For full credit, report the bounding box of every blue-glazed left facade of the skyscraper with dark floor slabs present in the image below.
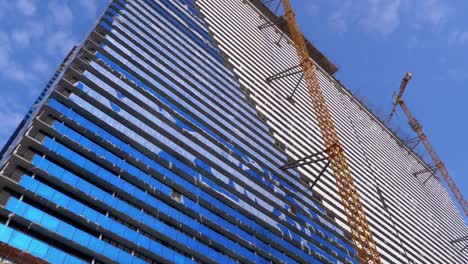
[0,0,358,264]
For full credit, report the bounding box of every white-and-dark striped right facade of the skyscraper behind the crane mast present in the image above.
[197,0,468,264]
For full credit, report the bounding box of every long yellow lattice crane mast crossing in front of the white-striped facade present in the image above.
[281,0,381,264]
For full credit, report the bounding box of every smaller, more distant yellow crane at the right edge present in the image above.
[387,73,468,216]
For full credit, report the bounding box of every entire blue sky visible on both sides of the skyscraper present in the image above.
[0,0,468,212]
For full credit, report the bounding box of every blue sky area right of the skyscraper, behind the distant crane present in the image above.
[292,0,468,208]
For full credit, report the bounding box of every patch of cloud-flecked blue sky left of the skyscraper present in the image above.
[0,0,107,146]
